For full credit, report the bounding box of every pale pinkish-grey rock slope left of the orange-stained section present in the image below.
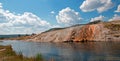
[29,26,82,42]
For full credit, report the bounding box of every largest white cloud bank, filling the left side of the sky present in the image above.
[0,3,50,34]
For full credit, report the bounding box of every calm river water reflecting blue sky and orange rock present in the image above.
[0,41,120,61]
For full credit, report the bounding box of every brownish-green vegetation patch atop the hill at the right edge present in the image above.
[105,21,120,31]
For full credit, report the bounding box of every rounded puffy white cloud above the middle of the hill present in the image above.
[56,7,82,25]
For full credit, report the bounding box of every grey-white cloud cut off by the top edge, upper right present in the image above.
[80,0,113,13]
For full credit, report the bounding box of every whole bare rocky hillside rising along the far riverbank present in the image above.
[24,21,120,42]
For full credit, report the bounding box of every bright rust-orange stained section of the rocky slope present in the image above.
[75,25,101,41]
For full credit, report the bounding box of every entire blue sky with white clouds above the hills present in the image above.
[0,0,120,34]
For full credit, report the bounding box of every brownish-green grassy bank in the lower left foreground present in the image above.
[0,45,43,61]
